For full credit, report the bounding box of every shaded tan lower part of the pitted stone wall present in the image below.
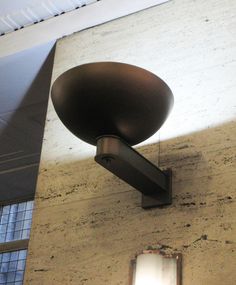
[26,119,236,285]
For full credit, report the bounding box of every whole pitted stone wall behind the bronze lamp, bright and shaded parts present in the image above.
[25,0,236,285]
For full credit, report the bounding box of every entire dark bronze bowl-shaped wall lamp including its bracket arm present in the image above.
[52,62,174,208]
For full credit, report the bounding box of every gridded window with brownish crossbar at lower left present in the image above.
[0,201,34,285]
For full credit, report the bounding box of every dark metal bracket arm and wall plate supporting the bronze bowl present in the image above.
[95,136,172,209]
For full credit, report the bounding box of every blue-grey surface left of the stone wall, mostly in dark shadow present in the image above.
[0,42,55,203]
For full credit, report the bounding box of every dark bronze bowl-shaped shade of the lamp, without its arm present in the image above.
[52,62,173,145]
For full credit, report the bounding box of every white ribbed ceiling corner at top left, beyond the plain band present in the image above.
[0,0,97,35]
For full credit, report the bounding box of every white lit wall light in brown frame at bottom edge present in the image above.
[129,250,182,285]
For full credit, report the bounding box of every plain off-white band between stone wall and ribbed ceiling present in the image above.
[0,0,170,57]
